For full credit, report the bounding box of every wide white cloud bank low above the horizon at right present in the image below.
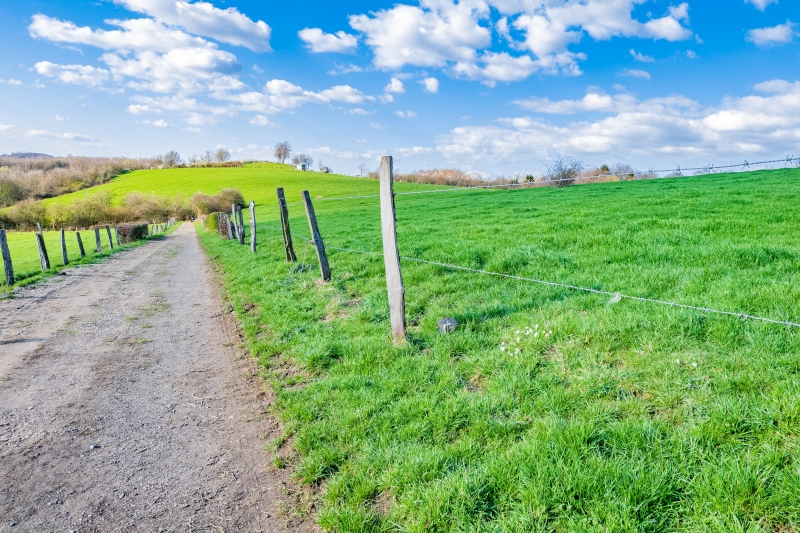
[437,80,800,163]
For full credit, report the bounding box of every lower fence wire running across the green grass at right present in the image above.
[260,227,800,328]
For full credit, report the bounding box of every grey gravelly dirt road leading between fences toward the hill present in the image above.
[0,224,308,532]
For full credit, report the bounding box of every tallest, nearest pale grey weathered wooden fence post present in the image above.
[380,156,406,341]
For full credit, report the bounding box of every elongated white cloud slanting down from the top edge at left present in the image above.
[115,0,272,52]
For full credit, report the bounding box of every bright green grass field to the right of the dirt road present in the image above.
[198,165,800,533]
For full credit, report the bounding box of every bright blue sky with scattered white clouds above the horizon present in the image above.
[0,0,800,175]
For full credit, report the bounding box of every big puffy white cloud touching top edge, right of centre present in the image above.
[349,0,692,85]
